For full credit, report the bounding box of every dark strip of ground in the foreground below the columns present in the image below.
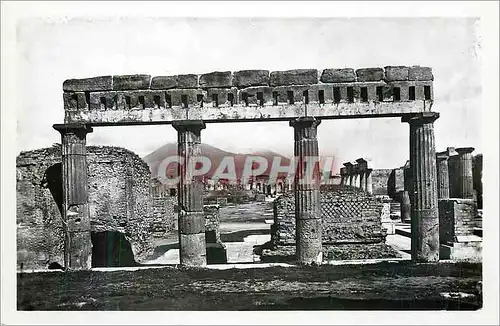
[17,262,482,310]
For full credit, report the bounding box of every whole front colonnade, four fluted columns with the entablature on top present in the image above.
[38,66,439,269]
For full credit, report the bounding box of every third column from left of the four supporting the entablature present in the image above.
[290,117,323,264]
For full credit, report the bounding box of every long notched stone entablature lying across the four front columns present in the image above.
[63,66,433,125]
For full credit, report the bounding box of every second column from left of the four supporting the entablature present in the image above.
[172,120,207,266]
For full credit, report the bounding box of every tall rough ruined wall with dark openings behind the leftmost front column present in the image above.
[17,146,172,268]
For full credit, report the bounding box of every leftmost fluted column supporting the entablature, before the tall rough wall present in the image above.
[53,124,92,270]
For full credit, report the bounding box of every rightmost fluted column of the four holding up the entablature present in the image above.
[402,112,439,262]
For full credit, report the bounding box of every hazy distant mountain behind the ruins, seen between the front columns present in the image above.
[143,143,334,183]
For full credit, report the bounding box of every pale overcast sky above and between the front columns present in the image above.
[17,18,483,168]
